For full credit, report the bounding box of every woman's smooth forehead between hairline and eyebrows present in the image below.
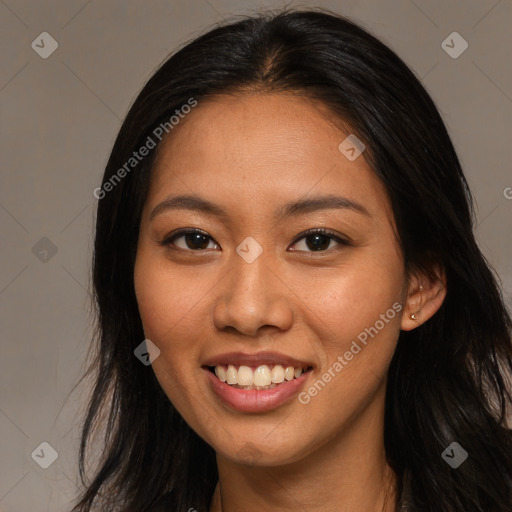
[148,93,389,217]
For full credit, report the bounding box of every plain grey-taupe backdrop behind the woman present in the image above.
[0,0,512,512]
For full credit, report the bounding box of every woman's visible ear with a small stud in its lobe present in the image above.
[401,265,446,331]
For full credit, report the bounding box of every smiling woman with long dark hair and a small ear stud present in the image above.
[74,11,512,512]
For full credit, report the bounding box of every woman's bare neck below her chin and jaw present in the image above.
[210,384,396,512]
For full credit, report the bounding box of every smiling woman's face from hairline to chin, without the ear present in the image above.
[135,94,407,465]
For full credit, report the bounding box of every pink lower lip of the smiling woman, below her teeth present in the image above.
[203,368,311,412]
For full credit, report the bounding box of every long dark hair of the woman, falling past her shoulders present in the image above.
[73,10,512,512]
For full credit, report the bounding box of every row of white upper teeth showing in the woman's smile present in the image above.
[215,364,304,389]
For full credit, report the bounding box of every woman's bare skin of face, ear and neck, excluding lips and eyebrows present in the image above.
[134,93,445,512]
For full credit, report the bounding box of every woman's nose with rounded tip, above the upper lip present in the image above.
[213,247,294,337]
